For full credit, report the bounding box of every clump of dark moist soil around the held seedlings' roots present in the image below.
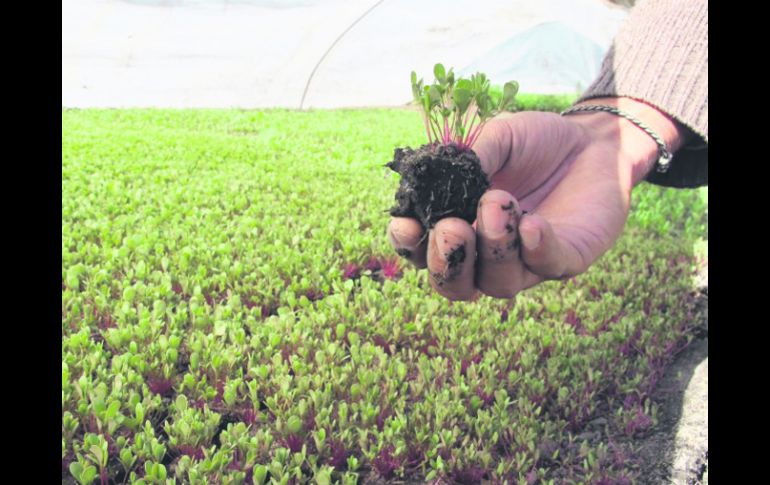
[385,145,489,229]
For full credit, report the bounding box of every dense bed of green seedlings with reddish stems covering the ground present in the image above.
[61,110,708,484]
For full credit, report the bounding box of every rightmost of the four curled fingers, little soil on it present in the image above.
[519,214,582,279]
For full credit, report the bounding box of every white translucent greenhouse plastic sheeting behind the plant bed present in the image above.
[62,0,628,108]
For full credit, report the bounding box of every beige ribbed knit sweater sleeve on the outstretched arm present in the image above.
[580,0,708,187]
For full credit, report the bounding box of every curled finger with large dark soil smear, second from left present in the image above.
[427,217,476,300]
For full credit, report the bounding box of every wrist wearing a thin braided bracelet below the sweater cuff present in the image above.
[570,97,689,185]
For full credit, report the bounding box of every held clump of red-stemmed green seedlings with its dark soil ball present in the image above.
[386,64,519,229]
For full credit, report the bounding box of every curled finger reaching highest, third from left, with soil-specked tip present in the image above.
[476,190,537,298]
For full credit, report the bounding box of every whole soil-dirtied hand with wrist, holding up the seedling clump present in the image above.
[388,98,685,300]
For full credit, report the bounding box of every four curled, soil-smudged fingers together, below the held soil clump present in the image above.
[388,200,586,300]
